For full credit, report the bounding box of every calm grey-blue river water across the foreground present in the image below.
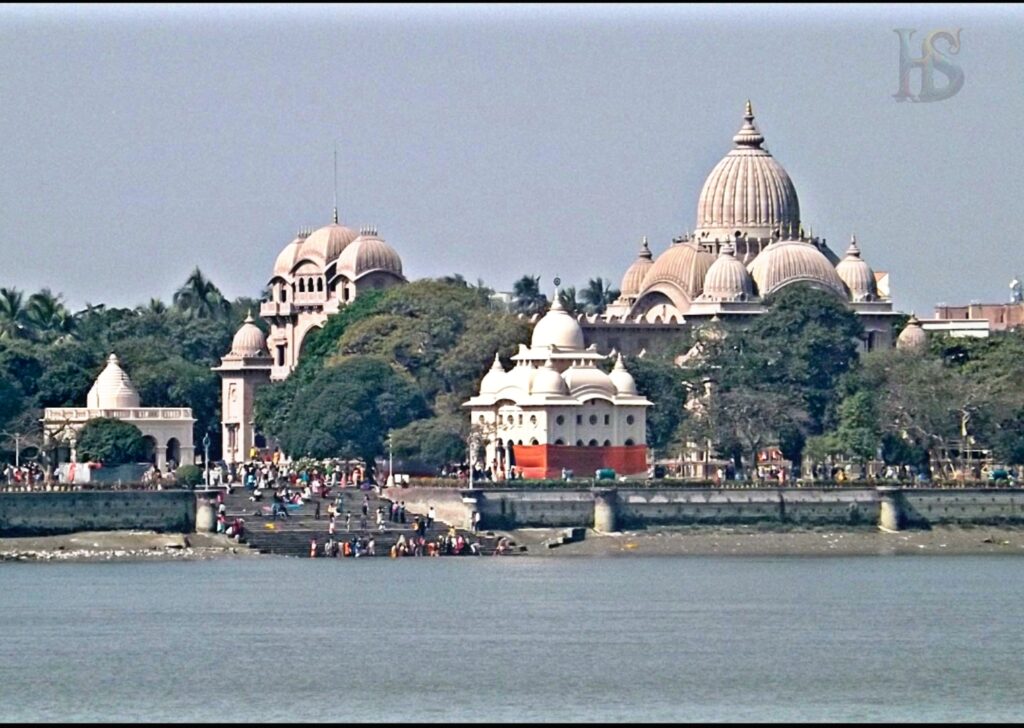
[0,556,1024,722]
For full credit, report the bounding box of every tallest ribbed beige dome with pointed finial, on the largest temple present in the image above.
[695,101,800,241]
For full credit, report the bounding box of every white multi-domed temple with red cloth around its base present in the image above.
[463,296,651,478]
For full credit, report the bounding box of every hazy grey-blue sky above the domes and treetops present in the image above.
[0,4,1024,315]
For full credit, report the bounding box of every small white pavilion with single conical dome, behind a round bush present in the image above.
[43,354,196,471]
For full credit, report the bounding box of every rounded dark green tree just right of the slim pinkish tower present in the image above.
[281,356,429,470]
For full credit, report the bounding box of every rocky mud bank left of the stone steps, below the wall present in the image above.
[0,531,258,561]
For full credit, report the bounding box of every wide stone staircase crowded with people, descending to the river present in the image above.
[224,487,516,558]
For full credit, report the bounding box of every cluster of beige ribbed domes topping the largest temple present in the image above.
[615,101,886,320]
